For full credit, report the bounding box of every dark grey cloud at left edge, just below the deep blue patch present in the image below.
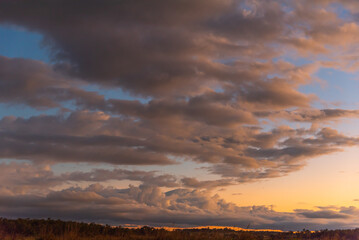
[0,56,108,109]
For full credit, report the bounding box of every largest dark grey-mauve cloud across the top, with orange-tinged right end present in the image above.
[0,0,326,100]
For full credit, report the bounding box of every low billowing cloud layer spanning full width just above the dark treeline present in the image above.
[0,163,359,230]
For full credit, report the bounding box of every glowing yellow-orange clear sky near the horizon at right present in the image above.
[220,147,359,211]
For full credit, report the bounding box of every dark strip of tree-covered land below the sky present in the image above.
[0,218,359,240]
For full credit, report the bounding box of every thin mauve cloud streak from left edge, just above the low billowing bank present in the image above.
[0,162,181,196]
